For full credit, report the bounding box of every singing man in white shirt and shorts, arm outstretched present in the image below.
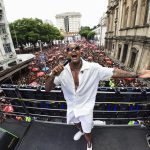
[45,43,150,150]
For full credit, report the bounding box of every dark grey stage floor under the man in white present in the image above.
[0,120,150,150]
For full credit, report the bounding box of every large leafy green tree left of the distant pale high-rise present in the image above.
[9,18,63,46]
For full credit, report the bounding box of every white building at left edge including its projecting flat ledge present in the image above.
[0,0,34,83]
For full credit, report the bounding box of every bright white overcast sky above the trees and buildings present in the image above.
[3,0,108,27]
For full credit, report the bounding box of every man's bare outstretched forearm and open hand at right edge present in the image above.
[112,68,150,78]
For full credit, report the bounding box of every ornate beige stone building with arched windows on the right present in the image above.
[105,0,150,72]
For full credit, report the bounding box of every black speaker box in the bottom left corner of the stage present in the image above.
[0,128,19,150]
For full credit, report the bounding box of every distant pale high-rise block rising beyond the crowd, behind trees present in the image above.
[56,12,81,34]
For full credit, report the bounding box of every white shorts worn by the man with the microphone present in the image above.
[69,112,93,133]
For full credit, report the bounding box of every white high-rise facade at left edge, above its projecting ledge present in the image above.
[0,0,17,71]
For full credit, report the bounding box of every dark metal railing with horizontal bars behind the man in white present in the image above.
[0,84,150,123]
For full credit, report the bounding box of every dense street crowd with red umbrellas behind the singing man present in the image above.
[16,41,147,87]
